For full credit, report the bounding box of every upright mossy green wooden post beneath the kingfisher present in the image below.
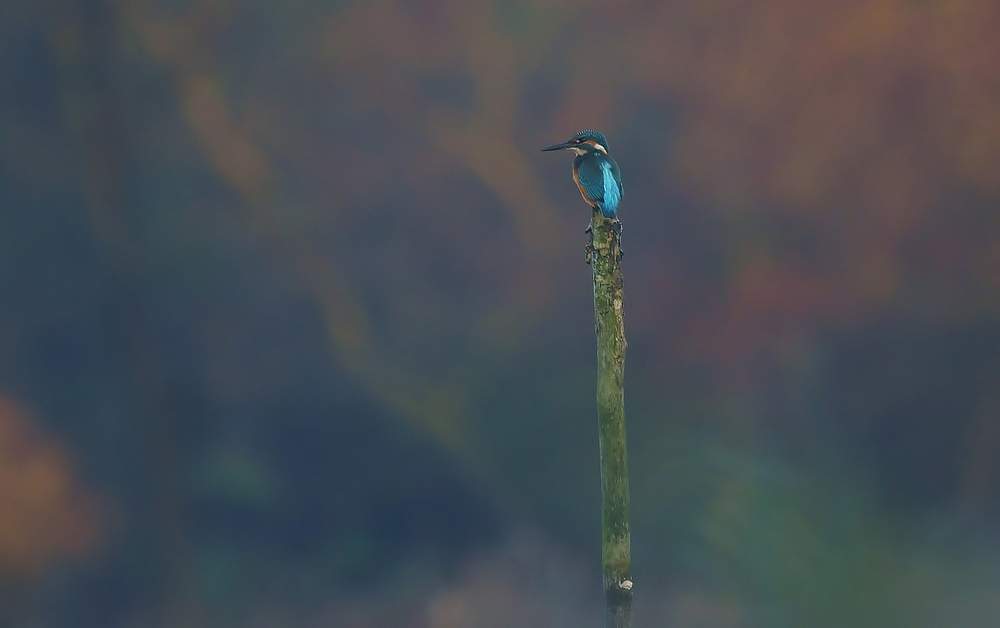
[587,212,632,628]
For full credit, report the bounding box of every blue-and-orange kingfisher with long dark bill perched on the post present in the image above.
[542,130,625,224]
